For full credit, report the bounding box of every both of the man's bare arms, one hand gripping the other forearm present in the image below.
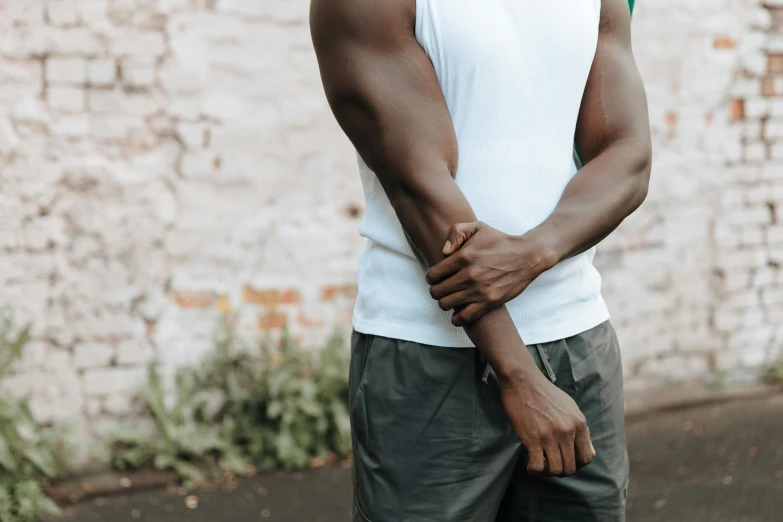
[311,0,650,475]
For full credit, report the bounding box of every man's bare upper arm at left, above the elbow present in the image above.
[311,0,457,188]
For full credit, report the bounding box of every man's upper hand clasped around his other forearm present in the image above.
[427,221,554,326]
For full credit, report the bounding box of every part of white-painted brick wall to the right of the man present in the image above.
[596,0,783,390]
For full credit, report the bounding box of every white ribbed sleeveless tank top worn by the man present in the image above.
[353,0,609,347]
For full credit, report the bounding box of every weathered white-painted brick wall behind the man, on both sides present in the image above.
[0,0,783,437]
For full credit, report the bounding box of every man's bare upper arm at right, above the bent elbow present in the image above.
[576,0,649,163]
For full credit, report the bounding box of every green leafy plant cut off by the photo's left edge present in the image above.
[0,313,67,522]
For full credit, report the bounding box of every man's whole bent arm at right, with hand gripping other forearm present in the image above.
[427,0,652,325]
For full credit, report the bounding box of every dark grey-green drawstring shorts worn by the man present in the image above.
[350,322,628,522]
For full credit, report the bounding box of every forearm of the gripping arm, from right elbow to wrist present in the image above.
[526,140,650,265]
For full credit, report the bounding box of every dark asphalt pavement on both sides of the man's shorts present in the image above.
[59,395,783,522]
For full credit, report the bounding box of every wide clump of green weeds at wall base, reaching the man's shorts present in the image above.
[110,332,351,484]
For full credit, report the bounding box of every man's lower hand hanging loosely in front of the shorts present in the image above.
[498,371,595,477]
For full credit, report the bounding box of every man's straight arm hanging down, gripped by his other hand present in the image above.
[310,0,648,476]
